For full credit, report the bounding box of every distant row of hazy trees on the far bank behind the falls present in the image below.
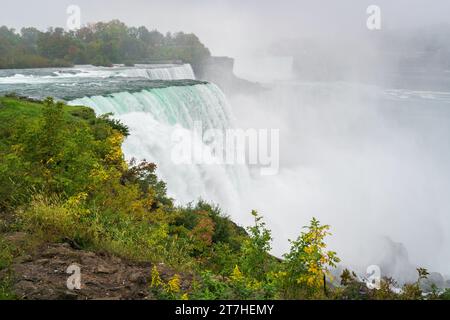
[0,20,210,69]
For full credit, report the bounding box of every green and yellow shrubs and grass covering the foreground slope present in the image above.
[0,97,448,299]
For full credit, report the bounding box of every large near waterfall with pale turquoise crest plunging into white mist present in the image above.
[69,83,249,214]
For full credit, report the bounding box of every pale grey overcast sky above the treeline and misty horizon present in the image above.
[0,0,450,56]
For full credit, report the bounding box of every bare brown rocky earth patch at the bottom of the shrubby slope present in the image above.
[8,244,183,300]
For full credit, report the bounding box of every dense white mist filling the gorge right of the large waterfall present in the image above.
[232,83,450,279]
